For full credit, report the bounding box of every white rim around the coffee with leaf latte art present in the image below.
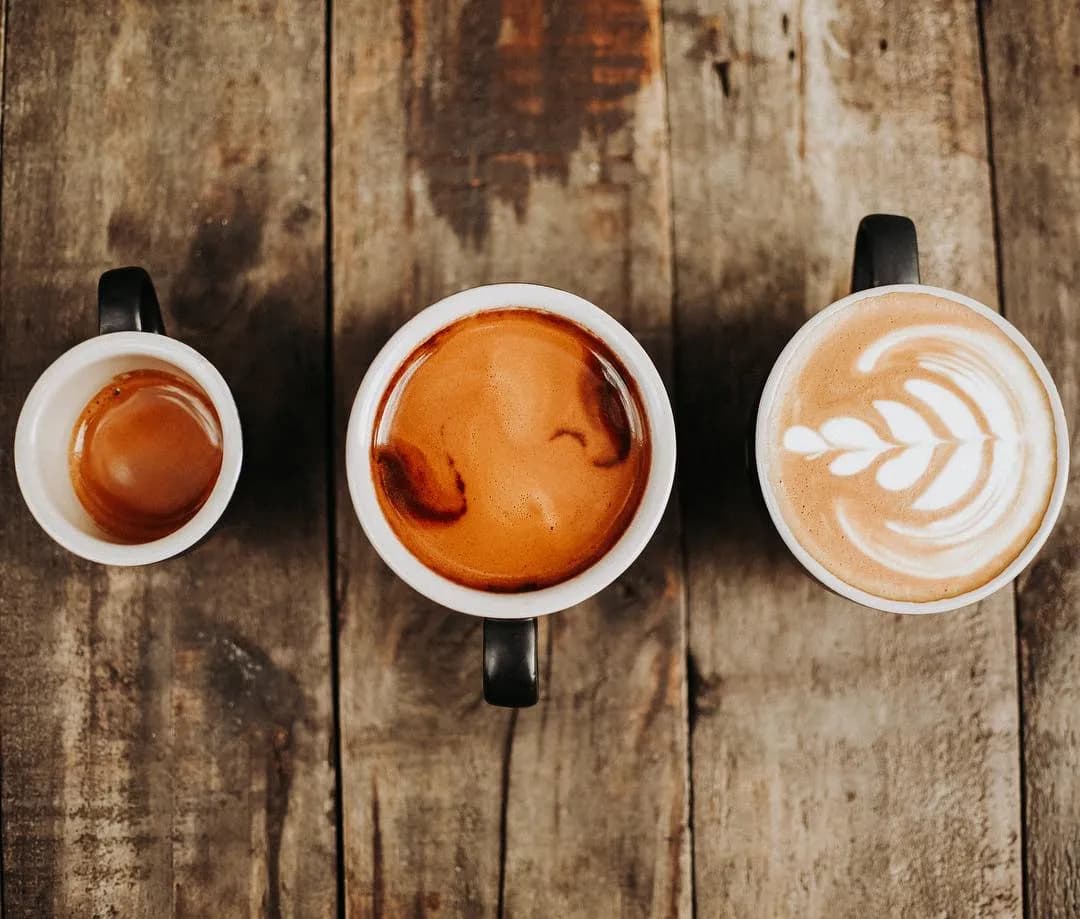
[754,284,1069,613]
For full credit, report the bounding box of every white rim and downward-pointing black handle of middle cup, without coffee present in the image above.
[346,284,675,707]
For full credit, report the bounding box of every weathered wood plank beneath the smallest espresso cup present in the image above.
[0,0,336,917]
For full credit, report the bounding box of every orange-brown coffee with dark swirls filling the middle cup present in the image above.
[372,308,649,592]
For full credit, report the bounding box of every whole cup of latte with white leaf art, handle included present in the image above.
[754,214,1069,613]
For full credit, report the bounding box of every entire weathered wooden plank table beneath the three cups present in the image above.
[0,0,1080,919]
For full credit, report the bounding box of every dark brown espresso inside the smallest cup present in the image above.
[69,369,221,543]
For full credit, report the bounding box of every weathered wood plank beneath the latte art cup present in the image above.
[664,0,1021,919]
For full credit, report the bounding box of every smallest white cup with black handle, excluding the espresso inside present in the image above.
[15,268,243,566]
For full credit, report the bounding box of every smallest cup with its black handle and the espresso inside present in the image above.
[15,268,243,566]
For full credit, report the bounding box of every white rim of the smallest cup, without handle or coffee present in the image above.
[15,332,243,566]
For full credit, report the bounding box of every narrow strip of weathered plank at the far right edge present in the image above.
[983,0,1080,917]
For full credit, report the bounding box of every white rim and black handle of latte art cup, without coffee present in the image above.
[754,214,1069,613]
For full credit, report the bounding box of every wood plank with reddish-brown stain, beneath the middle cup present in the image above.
[332,0,690,917]
